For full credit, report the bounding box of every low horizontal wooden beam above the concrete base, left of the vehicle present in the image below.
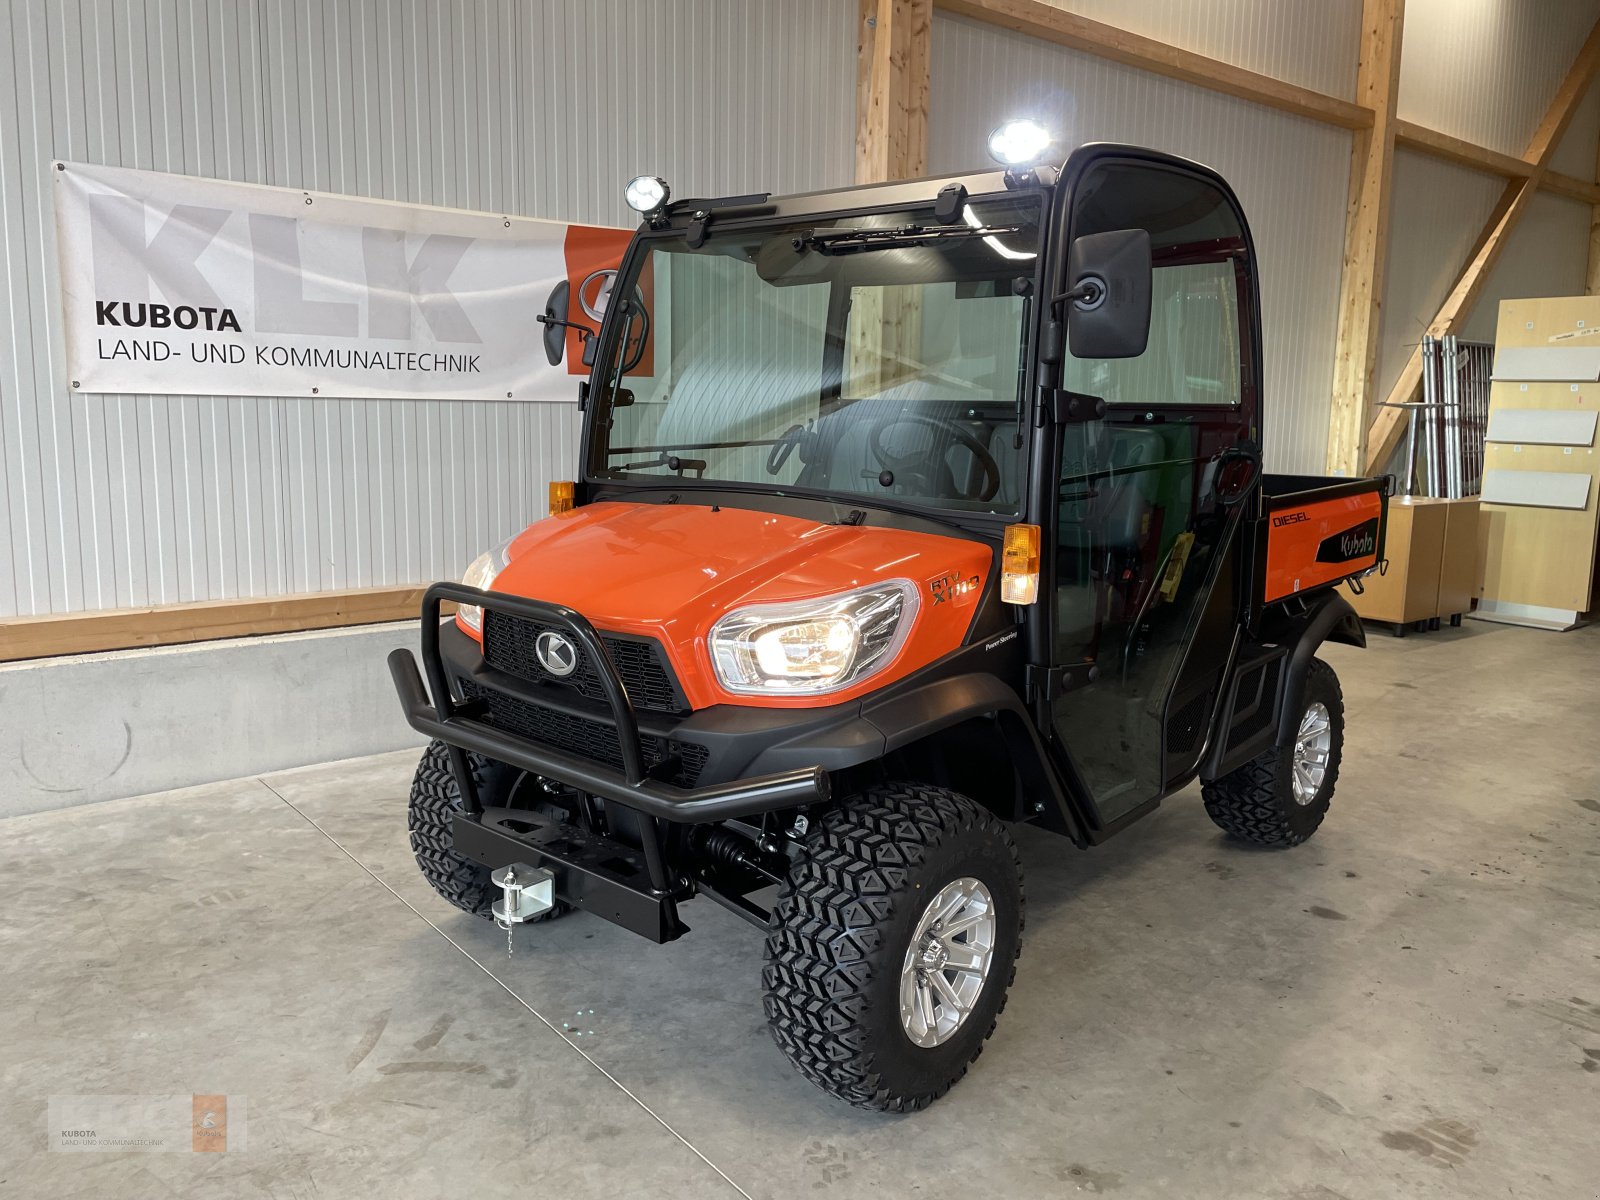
[0,586,441,662]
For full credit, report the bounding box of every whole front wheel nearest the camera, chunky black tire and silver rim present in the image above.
[762,782,1022,1112]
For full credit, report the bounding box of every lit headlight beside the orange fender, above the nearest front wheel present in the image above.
[710,579,917,696]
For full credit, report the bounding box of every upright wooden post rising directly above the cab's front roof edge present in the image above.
[856,0,933,184]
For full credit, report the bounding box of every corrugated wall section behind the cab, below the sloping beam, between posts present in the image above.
[930,14,1360,470]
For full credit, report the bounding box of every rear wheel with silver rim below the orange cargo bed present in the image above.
[1200,658,1344,846]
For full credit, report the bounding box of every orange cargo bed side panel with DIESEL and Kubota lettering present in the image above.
[1256,475,1390,605]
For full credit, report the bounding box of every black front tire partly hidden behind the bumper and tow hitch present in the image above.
[406,741,566,922]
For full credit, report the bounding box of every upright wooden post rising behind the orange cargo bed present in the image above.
[1328,0,1405,475]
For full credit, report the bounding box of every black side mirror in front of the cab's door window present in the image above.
[1062,229,1152,358]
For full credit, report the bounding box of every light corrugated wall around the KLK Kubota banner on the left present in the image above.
[0,0,856,616]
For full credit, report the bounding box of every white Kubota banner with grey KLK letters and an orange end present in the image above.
[54,163,629,402]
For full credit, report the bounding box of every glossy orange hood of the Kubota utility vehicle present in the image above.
[480,502,992,709]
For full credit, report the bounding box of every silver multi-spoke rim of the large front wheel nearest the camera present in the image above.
[899,875,998,1048]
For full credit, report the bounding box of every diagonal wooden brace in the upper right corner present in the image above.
[1363,22,1600,467]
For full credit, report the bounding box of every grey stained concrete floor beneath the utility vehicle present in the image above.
[0,621,1600,1200]
